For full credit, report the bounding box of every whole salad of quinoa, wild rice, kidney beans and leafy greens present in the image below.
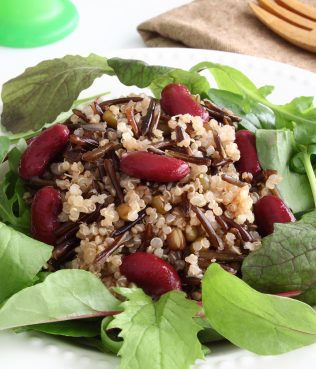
[0,54,316,369]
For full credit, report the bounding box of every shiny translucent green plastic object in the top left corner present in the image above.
[0,0,79,47]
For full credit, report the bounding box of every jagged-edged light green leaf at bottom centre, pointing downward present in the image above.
[109,288,203,369]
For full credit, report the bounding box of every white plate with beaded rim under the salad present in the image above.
[0,49,316,369]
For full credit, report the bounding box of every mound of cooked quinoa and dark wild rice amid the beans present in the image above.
[29,95,280,300]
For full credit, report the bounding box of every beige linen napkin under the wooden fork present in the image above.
[138,0,316,72]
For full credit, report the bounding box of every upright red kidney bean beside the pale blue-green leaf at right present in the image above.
[235,129,261,176]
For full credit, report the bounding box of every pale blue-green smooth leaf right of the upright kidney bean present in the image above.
[256,129,314,213]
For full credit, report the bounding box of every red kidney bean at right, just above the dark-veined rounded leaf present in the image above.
[254,195,295,236]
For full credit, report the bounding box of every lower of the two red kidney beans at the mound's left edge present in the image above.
[31,186,62,246]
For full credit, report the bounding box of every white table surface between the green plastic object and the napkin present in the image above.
[0,0,190,86]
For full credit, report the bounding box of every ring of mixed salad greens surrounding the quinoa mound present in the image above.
[0,54,316,369]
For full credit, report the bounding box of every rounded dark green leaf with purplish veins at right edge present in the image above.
[242,210,316,296]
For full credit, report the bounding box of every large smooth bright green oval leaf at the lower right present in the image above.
[202,264,316,355]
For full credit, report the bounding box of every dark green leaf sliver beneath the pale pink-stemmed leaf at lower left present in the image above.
[14,319,100,337]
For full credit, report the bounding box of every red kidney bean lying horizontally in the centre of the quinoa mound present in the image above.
[120,151,190,182]
